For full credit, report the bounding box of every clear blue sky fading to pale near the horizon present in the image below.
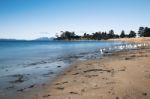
[0,0,150,39]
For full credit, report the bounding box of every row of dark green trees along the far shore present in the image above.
[55,27,150,40]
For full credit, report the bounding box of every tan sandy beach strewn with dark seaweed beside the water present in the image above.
[36,38,150,99]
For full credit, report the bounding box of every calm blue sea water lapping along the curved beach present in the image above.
[0,41,125,89]
